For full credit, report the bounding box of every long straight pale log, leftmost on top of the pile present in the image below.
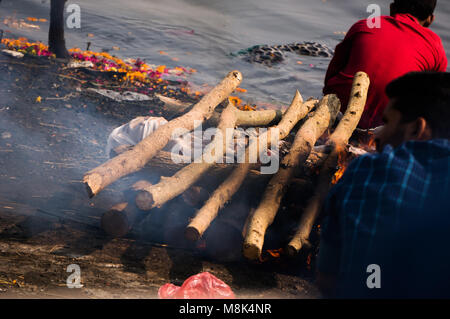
[83,71,242,197]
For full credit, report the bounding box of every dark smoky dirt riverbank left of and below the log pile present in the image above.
[0,50,320,298]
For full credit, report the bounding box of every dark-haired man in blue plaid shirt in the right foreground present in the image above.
[318,73,450,298]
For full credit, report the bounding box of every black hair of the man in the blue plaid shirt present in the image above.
[386,72,450,139]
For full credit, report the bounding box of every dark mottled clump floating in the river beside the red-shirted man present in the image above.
[233,42,334,66]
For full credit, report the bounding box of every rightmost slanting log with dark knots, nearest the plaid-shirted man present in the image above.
[287,72,370,256]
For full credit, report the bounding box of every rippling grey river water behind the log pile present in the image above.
[0,0,450,105]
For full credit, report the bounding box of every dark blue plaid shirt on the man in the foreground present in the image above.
[319,139,450,298]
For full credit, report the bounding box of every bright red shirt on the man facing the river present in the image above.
[324,14,447,128]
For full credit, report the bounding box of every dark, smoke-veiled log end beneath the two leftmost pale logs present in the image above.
[101,181,150,237]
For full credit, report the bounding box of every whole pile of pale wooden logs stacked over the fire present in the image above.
[84,71,370,260]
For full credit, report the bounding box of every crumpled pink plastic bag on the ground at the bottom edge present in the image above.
[158,272,236,299]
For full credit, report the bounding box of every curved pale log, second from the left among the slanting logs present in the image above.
[136,103,236,210]
